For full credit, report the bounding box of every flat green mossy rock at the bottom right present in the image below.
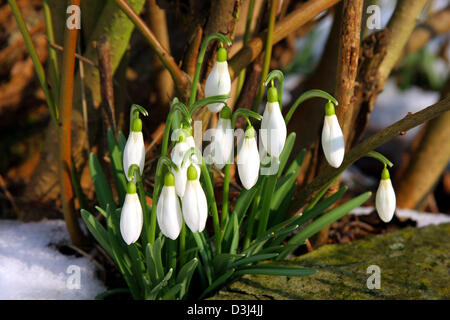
[212,224,450,300]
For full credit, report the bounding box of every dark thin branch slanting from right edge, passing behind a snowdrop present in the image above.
[292,96,450,210]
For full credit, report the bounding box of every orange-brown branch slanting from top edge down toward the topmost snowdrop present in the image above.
[229,0,340,78]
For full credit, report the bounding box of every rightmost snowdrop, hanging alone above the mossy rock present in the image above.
[375,166,396,222]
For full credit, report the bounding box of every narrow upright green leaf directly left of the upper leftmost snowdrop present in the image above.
[108,129,127,203]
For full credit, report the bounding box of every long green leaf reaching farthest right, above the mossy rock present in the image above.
[278,192,372,259]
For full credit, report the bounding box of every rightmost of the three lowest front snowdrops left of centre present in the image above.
[182,165,208,232]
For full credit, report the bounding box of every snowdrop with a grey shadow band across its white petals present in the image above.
[322,101,345,168]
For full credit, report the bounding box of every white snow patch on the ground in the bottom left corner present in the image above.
[0,220,106,300]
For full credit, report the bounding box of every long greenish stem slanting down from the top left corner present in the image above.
[8,0,58,126]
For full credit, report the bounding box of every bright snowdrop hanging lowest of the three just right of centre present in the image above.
[237,126,260,190]
